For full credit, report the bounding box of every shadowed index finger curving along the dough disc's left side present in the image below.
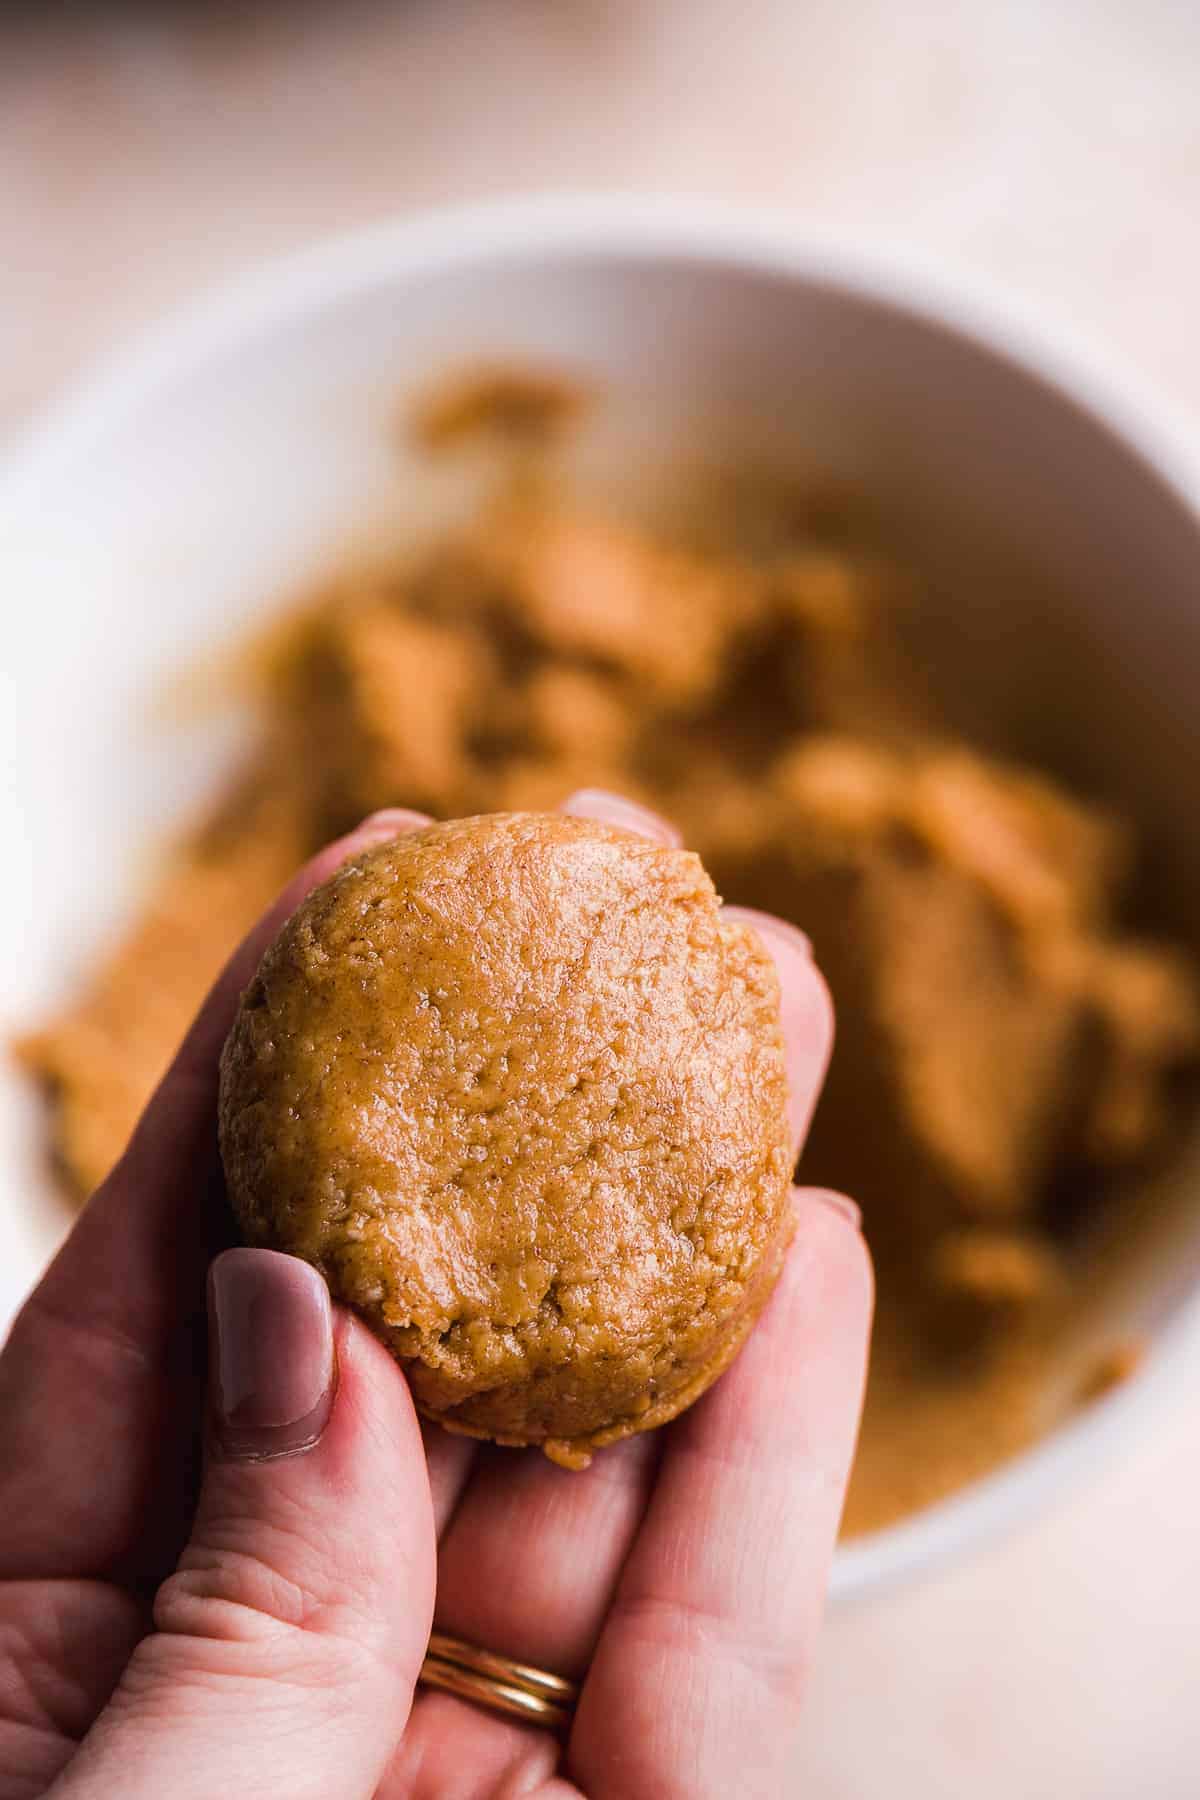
[0,814,425,1577]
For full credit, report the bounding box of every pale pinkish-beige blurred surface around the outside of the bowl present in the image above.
[0,0,1200,1800]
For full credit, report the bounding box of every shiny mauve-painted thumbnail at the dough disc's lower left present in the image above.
[209,1249,335,1462]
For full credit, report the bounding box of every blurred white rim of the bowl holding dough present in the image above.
[0,193,1200,1600]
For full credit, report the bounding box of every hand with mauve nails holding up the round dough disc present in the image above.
[0,796,871,1800]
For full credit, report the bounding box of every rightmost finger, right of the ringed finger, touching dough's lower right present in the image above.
[570,1193,871,1800]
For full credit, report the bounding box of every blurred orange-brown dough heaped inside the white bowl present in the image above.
[22,371,1196,1530]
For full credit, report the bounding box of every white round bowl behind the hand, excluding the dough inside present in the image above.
[0,200,1200,1593]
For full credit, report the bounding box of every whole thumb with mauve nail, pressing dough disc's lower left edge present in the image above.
[56,1249,435,1800]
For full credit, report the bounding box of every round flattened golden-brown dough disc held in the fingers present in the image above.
[219,814,792,1465]
